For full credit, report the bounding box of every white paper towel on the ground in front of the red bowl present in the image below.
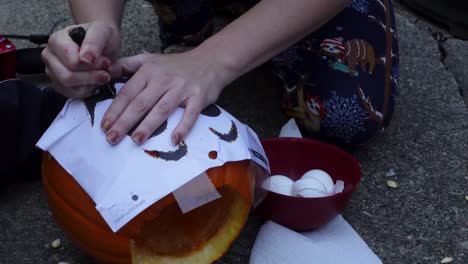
[250,215,382,264]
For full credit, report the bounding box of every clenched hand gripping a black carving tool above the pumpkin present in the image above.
[42,22,120,98]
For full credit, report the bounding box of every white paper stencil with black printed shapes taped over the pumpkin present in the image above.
[37,84,269,231]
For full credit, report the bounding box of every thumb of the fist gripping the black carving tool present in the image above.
[80,22,115,64]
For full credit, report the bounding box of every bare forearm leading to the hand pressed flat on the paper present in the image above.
[198,0,350,78]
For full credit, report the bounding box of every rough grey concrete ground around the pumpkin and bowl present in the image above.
[0,0,468,264]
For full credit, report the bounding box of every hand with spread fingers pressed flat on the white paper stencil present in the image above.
[101,50,233,144]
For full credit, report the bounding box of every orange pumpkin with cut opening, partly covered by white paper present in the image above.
[42,153,258,263]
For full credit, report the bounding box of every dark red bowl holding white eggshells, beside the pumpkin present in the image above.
[255,138,362,231]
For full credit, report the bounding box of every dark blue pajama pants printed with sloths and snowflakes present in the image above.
[147,0,399,146]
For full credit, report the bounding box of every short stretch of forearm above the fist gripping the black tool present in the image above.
[68,0,125,29]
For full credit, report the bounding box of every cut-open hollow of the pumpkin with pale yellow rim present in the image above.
[131,187,250,264]
